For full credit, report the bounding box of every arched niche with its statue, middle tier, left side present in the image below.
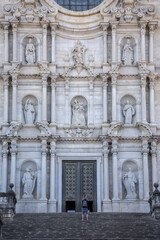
[22,95,38,125]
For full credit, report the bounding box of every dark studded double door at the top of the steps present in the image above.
[62,161,97,212]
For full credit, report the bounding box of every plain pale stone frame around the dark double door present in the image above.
[57,154,103,213]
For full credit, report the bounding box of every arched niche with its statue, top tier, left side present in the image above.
[21,36,38,65]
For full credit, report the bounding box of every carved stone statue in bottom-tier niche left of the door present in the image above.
[22,168,36,199]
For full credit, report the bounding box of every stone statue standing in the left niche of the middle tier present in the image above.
[24,99,36,124]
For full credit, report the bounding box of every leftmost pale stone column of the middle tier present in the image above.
[3,74,9,123]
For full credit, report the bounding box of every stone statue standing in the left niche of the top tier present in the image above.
[25,38,36,64]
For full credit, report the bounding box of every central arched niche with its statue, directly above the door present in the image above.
[71,96,88,127]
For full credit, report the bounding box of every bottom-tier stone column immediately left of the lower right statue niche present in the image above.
[112,138,119,200]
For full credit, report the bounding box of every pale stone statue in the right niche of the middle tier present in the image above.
[123,100,135,124]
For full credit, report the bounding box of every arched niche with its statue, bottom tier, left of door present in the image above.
[20,160,37,199]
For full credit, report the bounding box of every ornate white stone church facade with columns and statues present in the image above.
[0,0,160,212]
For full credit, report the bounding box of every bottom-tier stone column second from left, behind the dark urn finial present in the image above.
[10,139,17,189]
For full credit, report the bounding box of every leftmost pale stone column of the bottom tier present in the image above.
[2,141,8,192]
